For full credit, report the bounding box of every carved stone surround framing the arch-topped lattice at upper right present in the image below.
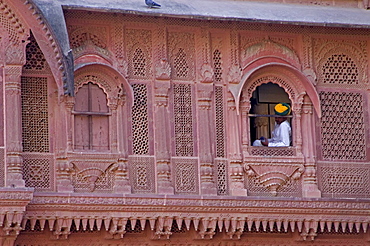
[316,40,368,84]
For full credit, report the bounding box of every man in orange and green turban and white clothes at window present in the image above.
[253,103,292,147]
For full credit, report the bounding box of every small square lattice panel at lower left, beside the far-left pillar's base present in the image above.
[23,154,54,191]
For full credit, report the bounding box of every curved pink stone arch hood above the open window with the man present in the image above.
[229,62,321,118]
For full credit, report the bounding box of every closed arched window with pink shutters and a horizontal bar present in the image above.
[73,82,110,151]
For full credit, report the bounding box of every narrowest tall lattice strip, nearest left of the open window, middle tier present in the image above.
[215,86,226,157]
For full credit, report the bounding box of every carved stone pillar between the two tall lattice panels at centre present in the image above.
[154,80,174,194]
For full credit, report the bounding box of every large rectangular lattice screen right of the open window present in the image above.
[320,92,366,160]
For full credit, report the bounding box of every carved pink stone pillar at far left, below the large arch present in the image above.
[5,65,25,187]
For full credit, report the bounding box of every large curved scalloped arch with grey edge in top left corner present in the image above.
[4,0,73,95]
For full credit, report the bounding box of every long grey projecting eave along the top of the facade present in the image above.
[57,0,370,28]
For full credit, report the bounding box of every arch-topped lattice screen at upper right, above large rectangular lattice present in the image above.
[322,54,359,85]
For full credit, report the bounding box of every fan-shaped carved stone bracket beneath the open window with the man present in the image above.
[244,163,304,196]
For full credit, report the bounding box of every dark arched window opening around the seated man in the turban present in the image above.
[249,82,292,147]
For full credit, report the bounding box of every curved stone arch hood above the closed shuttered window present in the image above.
[75,63,134,108]
